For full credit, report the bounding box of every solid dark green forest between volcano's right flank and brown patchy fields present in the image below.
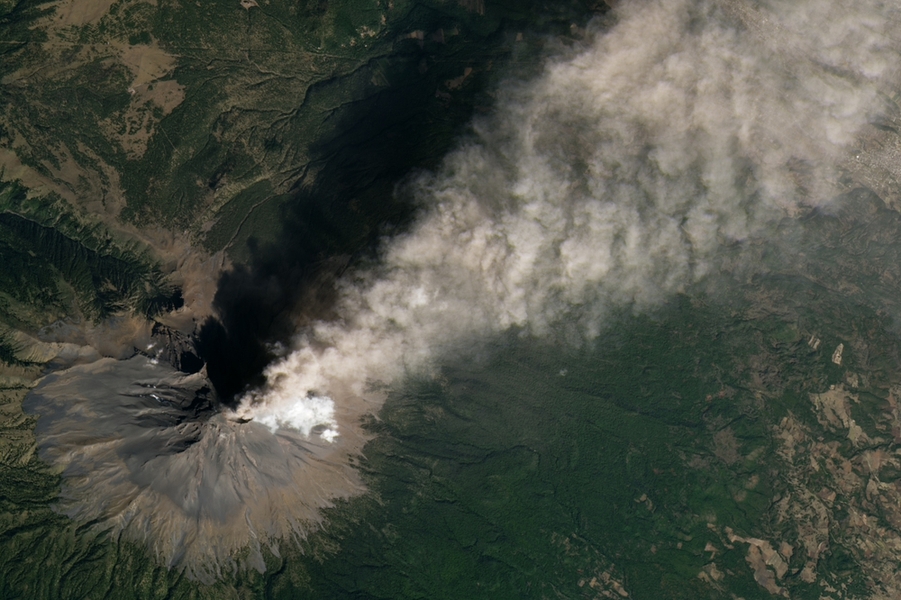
[294,281,899,599]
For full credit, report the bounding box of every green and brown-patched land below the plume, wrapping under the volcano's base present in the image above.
[8,193,901,599]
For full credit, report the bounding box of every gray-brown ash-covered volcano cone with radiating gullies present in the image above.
[24,356,360,581]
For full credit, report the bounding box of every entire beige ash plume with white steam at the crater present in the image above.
[239,0,899,438]
